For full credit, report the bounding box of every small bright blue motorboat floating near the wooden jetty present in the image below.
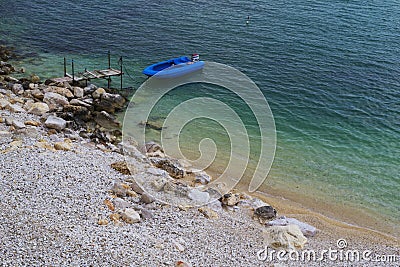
[143,54,204,78]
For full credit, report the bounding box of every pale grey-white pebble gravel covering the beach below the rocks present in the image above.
[0,111,400,266]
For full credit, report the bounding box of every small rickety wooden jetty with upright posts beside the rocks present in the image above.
[51,51,124,89]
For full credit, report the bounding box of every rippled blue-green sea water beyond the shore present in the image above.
[0,0,400,232]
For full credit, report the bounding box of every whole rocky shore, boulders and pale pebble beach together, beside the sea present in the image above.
[0,48,398,266]
